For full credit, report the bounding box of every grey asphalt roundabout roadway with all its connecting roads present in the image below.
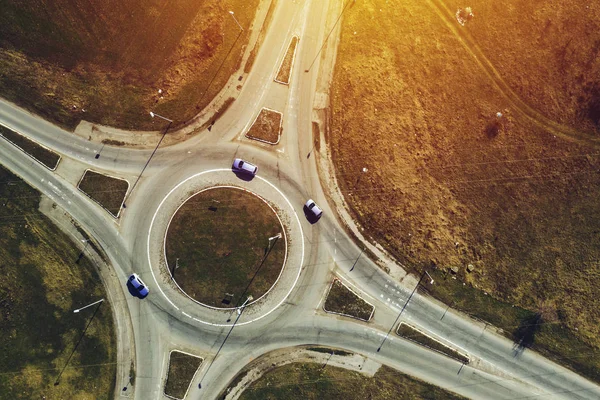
[0,0,600,399]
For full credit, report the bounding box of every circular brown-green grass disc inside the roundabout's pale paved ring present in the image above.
[166,188,286,307]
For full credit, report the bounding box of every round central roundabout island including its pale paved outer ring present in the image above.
[146,169,305,327]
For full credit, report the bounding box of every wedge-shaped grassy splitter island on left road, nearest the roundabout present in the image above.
[77,169,129,218]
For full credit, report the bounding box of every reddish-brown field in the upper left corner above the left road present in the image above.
[0,0,259,129]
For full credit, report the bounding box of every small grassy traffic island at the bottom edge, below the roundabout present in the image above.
[165,350,202,399]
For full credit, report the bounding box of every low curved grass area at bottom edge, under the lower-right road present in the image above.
[240,363,463,400]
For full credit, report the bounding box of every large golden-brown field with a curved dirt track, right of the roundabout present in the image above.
[328,0,600,379]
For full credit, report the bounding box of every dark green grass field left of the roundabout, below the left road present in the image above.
[0,167,116,400]
